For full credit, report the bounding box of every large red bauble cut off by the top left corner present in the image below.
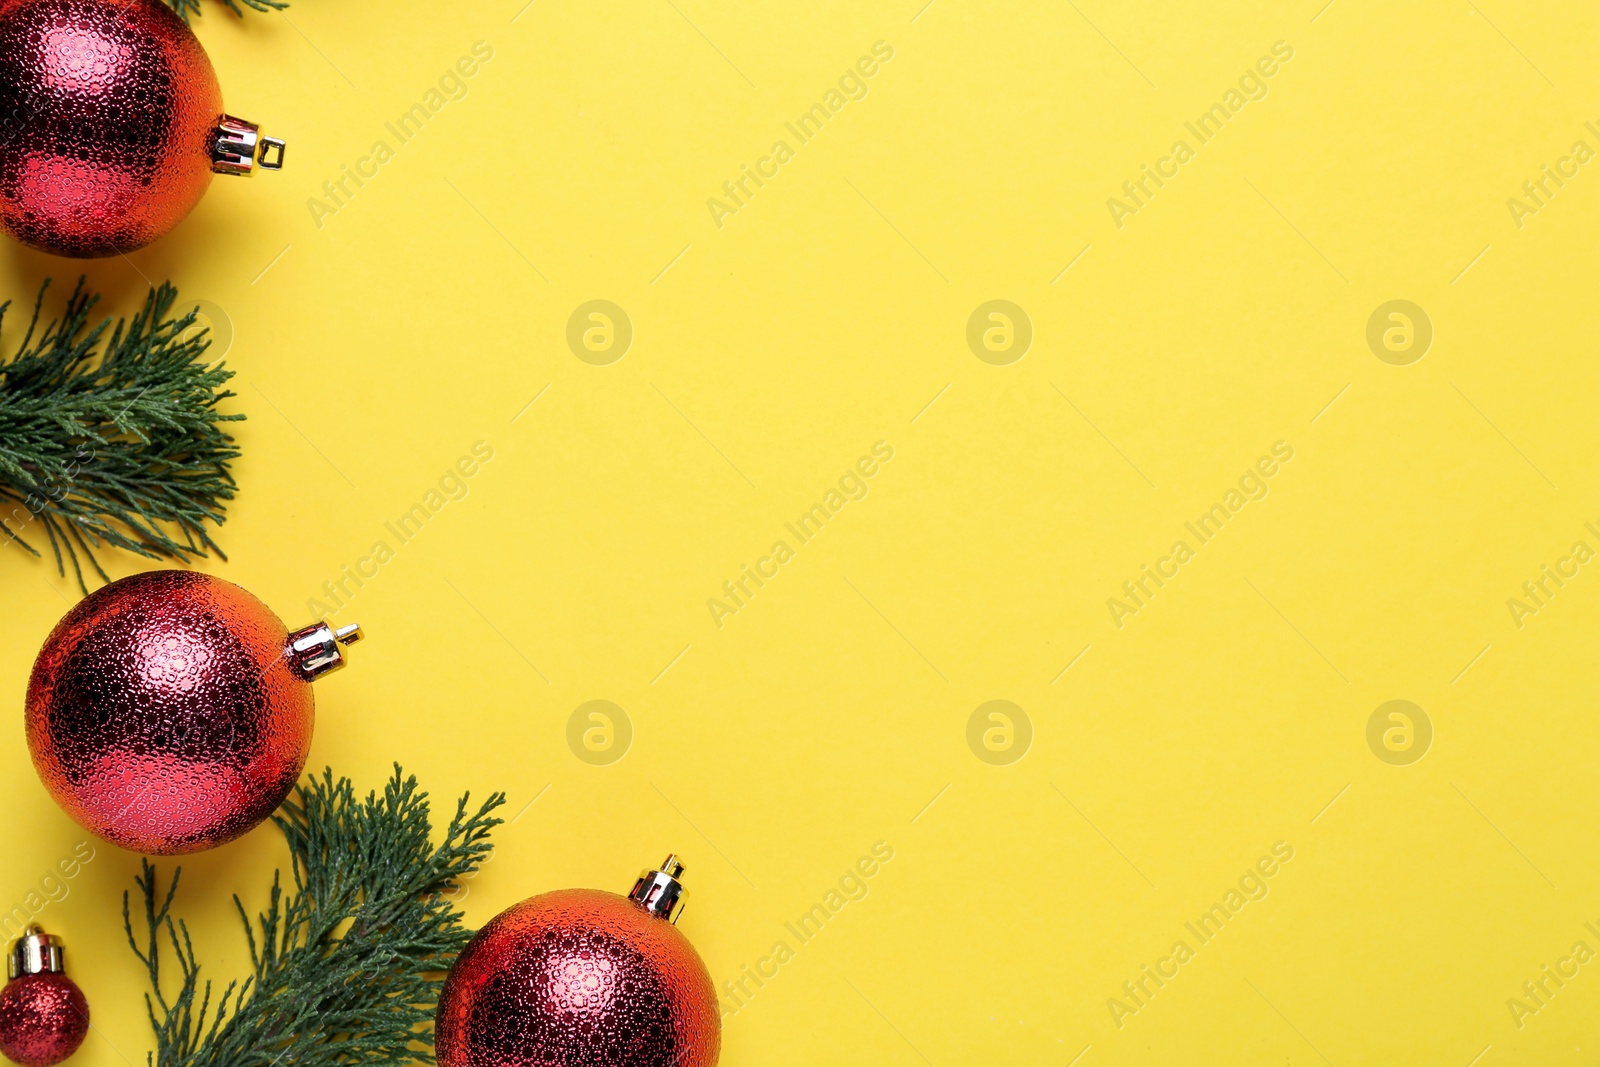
[0,0,283,256]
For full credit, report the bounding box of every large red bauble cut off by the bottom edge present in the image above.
[434,856,722,1067]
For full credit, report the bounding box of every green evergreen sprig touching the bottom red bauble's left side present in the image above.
[122,763,506,1067]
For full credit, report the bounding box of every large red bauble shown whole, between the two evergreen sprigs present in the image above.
[27,571,360,856]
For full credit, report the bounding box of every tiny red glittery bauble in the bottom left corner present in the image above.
[0,926,90,1067]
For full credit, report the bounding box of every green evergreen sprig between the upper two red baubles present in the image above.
[0,278,245,592]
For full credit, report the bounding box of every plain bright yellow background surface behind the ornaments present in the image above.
[0,0,1600,1067]
